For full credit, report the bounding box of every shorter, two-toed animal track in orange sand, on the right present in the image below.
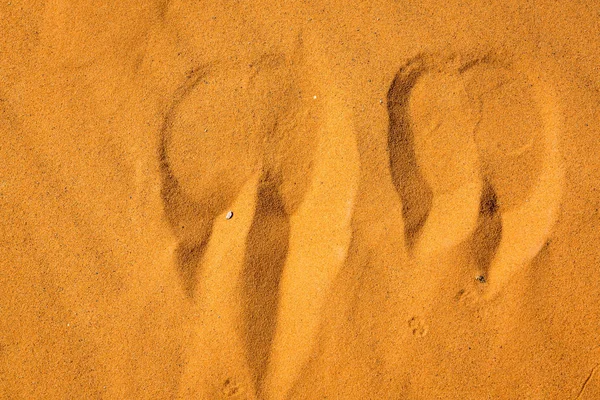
[388,55,564,296]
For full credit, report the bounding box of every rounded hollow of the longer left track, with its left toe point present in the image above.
[159,55,310,297]
